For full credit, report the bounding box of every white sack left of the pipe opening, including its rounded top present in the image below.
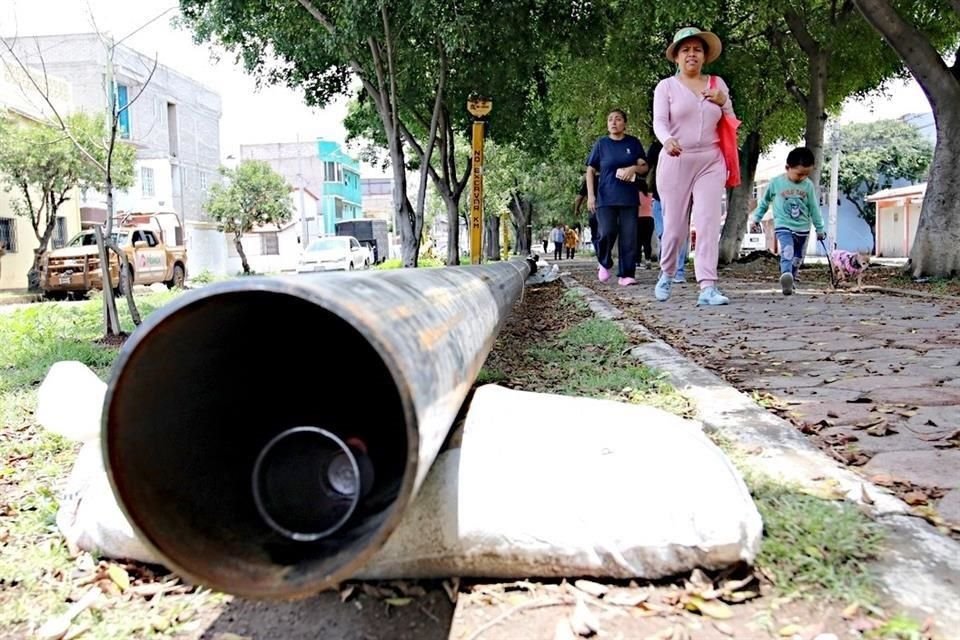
[37,360,158,563]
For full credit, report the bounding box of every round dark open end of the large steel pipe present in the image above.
[105,290,408,595]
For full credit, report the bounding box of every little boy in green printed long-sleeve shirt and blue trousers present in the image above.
[752,147,827,296]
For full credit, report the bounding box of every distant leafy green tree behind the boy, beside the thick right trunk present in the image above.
[827,120,933,230]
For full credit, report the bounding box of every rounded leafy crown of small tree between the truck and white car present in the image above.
[206,160,293,238]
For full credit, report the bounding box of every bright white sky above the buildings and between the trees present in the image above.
[0,0,930,177]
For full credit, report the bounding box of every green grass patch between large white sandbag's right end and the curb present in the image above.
[747,474,883,604]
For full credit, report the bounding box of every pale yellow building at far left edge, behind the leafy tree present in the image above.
[0,64,80,289]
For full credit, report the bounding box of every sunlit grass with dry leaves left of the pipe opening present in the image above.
[0,291,227,639]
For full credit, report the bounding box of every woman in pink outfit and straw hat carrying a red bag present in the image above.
[653,27,733,305]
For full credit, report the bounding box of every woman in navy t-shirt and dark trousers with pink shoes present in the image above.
[584,109,647,286]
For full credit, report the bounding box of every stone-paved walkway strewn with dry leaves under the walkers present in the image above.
[560,261,960,525]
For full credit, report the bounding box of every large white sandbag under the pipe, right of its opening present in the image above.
[357,385,762,579]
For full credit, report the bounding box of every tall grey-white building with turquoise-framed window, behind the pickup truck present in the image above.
[5,33,227,273]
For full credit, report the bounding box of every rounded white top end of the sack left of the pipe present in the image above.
[37,360,107,442]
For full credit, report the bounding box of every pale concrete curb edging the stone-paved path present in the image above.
[562,275,960,637]
